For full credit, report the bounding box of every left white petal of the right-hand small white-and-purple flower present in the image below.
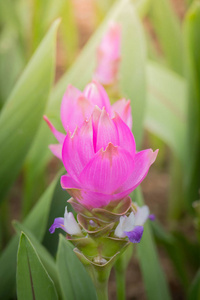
[115,212,135,238]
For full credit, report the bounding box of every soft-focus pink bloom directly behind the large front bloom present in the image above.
[44,81,132,159]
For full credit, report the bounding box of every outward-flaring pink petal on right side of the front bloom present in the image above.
[115,149,158,193]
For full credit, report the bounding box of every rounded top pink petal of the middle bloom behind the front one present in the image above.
[83,81,111,114]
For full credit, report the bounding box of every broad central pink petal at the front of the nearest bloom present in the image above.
[79,143,134,194]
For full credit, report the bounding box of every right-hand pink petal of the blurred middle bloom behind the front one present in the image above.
[112,99,132,129]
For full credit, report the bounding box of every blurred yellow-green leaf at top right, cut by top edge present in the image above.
[148,0,183,74]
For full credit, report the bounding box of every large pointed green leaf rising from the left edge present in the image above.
[0,21,58,199]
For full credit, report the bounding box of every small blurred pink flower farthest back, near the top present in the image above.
[94,23,121,85]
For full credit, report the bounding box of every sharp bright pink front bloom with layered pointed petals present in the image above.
[61,106,158,208]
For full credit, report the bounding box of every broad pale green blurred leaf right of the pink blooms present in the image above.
[145,62,186,166]
